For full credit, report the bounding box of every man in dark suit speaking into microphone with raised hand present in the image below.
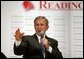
[14,16,63,58]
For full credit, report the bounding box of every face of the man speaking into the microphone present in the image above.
[34,19,48,35]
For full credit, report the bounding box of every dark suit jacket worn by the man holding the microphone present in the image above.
[14,34,63,58]
